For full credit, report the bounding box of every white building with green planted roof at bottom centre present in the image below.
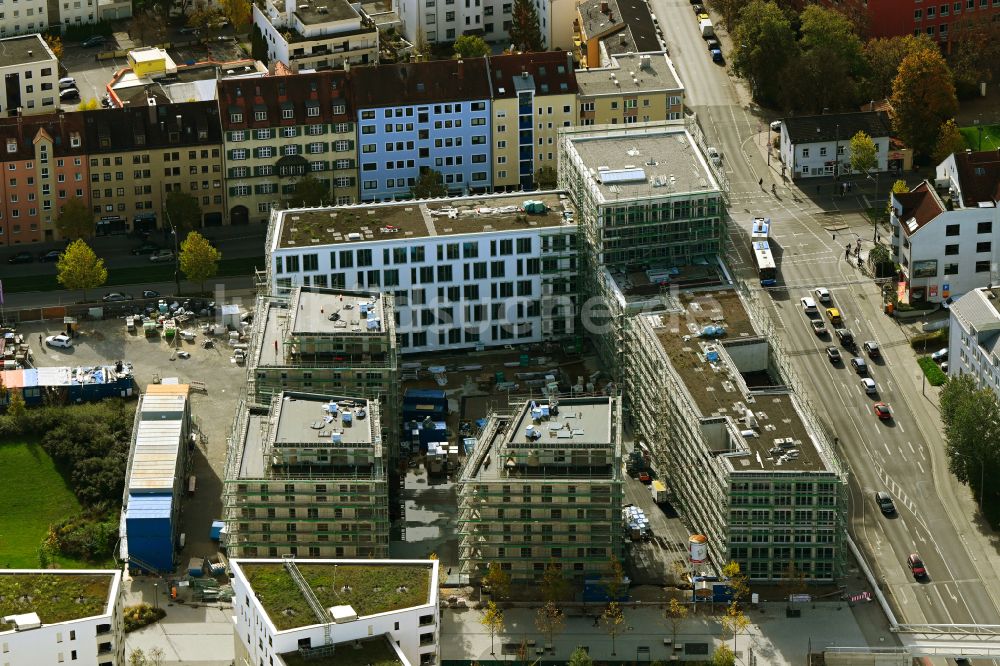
[230,558,440,666]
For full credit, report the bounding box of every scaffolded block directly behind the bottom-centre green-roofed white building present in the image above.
[223,391,389,558]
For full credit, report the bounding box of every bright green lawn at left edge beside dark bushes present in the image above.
[0,443,83,569]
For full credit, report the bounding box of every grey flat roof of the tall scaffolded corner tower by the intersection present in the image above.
[560,125,721,204]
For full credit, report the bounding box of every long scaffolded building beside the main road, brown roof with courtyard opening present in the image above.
[623,290,847,582]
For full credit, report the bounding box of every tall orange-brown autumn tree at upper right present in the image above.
[892,47,958,155]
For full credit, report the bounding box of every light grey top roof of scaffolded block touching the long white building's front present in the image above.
[291,287,386,335]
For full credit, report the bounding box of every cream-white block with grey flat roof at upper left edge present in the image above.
[0,34,59,115]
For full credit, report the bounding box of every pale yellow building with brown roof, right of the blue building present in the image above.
[489,51,577,191]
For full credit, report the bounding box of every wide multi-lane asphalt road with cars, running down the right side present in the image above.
[651,0,1000,648]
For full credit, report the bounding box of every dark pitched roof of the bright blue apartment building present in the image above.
[350,58,490,108]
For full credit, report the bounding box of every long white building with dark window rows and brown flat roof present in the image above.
[267,192,578,353]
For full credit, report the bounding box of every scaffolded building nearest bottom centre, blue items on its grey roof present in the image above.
[458,396,623,583]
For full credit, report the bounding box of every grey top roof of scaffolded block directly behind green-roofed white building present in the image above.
[272,392,381,448]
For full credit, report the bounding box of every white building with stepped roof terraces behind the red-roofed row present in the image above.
[253,0,378,71]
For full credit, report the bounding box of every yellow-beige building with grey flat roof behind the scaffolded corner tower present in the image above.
[576,53,684,125]
